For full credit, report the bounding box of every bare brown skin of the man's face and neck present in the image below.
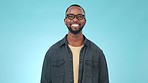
[64,6,86,47]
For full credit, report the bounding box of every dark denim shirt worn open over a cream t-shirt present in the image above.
[40,36,109,83]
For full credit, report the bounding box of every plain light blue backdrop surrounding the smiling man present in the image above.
[0,0,148,83]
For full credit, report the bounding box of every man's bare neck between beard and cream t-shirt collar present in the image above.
[67,32,84,47]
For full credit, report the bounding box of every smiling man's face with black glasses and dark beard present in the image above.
[64,6,86,34]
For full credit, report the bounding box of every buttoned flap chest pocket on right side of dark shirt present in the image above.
[85,60,98,78]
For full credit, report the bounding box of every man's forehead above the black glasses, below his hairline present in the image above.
[67,6,84,14]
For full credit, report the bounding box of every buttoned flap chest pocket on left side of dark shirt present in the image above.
[52,59,65,77]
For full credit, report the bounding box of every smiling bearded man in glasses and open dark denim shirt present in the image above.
[41,4,109,83]
